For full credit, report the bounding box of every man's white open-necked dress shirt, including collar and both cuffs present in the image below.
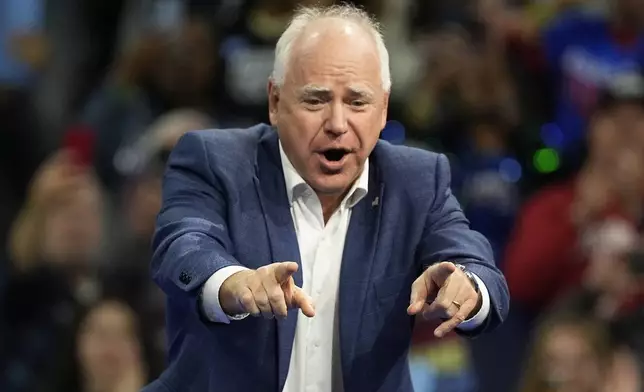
[202,144,490,392]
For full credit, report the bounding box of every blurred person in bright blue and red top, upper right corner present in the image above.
[483,0,644,162]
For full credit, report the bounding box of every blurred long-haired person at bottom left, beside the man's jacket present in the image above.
[50,296,150,392]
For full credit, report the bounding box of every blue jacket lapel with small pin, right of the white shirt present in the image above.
[338,158,385,386]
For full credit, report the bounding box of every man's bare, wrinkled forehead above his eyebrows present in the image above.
[285,20,381,89]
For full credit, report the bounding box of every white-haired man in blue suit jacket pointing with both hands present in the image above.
[148,6,508,392]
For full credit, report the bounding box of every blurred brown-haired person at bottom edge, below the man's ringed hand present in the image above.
[519,310,612,392]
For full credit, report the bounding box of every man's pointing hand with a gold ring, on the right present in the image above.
[407,262,482,338]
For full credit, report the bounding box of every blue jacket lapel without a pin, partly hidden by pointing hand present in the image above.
[251,131,302,391]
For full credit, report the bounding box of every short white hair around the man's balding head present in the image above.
[271,4,391,91]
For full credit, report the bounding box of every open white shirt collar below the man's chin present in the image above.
[279,141,369,208]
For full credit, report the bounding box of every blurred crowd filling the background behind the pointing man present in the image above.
[0,0,644,392]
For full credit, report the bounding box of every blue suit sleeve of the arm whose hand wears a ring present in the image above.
[417,155,510,335]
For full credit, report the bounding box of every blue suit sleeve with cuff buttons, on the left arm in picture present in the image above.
[152,133,241,318]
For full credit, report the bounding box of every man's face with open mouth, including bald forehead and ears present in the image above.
[269,19,389,195]
